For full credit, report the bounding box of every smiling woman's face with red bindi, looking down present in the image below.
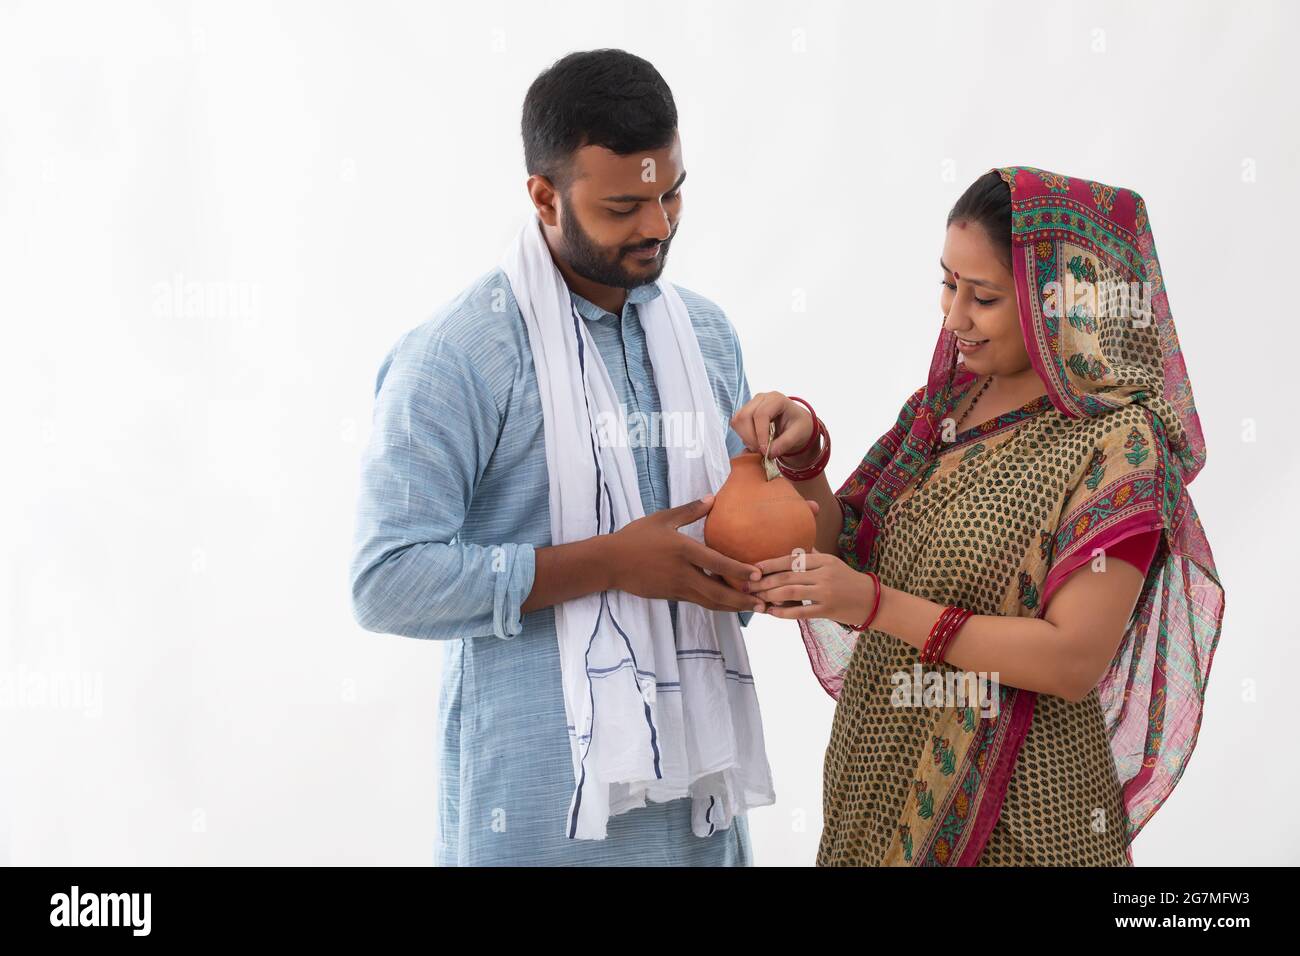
[939,222,1030,377]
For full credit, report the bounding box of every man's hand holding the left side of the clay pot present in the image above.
[610,494,764,611]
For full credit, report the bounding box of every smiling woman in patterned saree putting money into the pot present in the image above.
[732,166,1223,866]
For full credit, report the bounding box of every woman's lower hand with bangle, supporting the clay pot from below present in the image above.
[749,550,876,626]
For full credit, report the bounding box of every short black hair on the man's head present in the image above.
[521,49,677,191]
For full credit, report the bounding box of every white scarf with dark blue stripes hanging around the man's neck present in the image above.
[502,216,776,839]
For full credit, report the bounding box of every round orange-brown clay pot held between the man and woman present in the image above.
[705,451,816,591]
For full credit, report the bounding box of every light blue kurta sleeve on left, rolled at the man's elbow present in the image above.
[351,329,534,640]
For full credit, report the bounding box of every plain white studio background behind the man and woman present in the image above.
[0,1,1300,865]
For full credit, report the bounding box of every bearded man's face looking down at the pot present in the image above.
[558,137,686,289]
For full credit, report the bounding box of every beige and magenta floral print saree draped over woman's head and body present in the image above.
[800,168,1223,865]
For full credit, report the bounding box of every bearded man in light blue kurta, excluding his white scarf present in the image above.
[352,49,762,865]
